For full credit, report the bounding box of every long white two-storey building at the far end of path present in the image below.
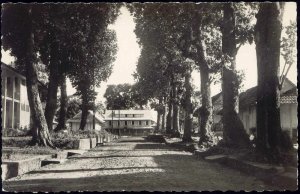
[104,110,156,135]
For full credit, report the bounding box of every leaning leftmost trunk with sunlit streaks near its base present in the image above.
[24,8,54,148]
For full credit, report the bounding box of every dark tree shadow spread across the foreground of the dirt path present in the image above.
[3,152,281,192]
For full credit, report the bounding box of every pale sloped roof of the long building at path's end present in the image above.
[104,109,155,121]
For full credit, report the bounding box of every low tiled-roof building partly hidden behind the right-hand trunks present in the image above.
[212,79,298,141]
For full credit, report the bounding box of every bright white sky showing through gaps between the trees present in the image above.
[1,2,297,102]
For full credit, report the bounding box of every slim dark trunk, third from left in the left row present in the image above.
[55,76,68,131]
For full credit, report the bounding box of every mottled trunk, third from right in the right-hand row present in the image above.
[199,64,214,147]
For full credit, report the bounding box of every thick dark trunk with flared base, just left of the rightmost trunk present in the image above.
[222,3,249,146]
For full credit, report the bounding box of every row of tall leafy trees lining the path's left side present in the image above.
[1,3,119,147]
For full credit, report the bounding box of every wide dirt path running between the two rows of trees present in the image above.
[3,138,276,191]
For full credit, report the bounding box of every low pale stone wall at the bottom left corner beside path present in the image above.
[1,155,52,180]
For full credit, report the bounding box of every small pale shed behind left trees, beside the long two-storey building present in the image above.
[67,111,104,131]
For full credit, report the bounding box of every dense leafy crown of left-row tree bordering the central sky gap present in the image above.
[69,4,119,113]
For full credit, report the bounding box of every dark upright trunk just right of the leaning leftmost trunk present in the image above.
[45,41,59,131]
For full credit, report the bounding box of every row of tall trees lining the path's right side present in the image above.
[128,3,295,161]
